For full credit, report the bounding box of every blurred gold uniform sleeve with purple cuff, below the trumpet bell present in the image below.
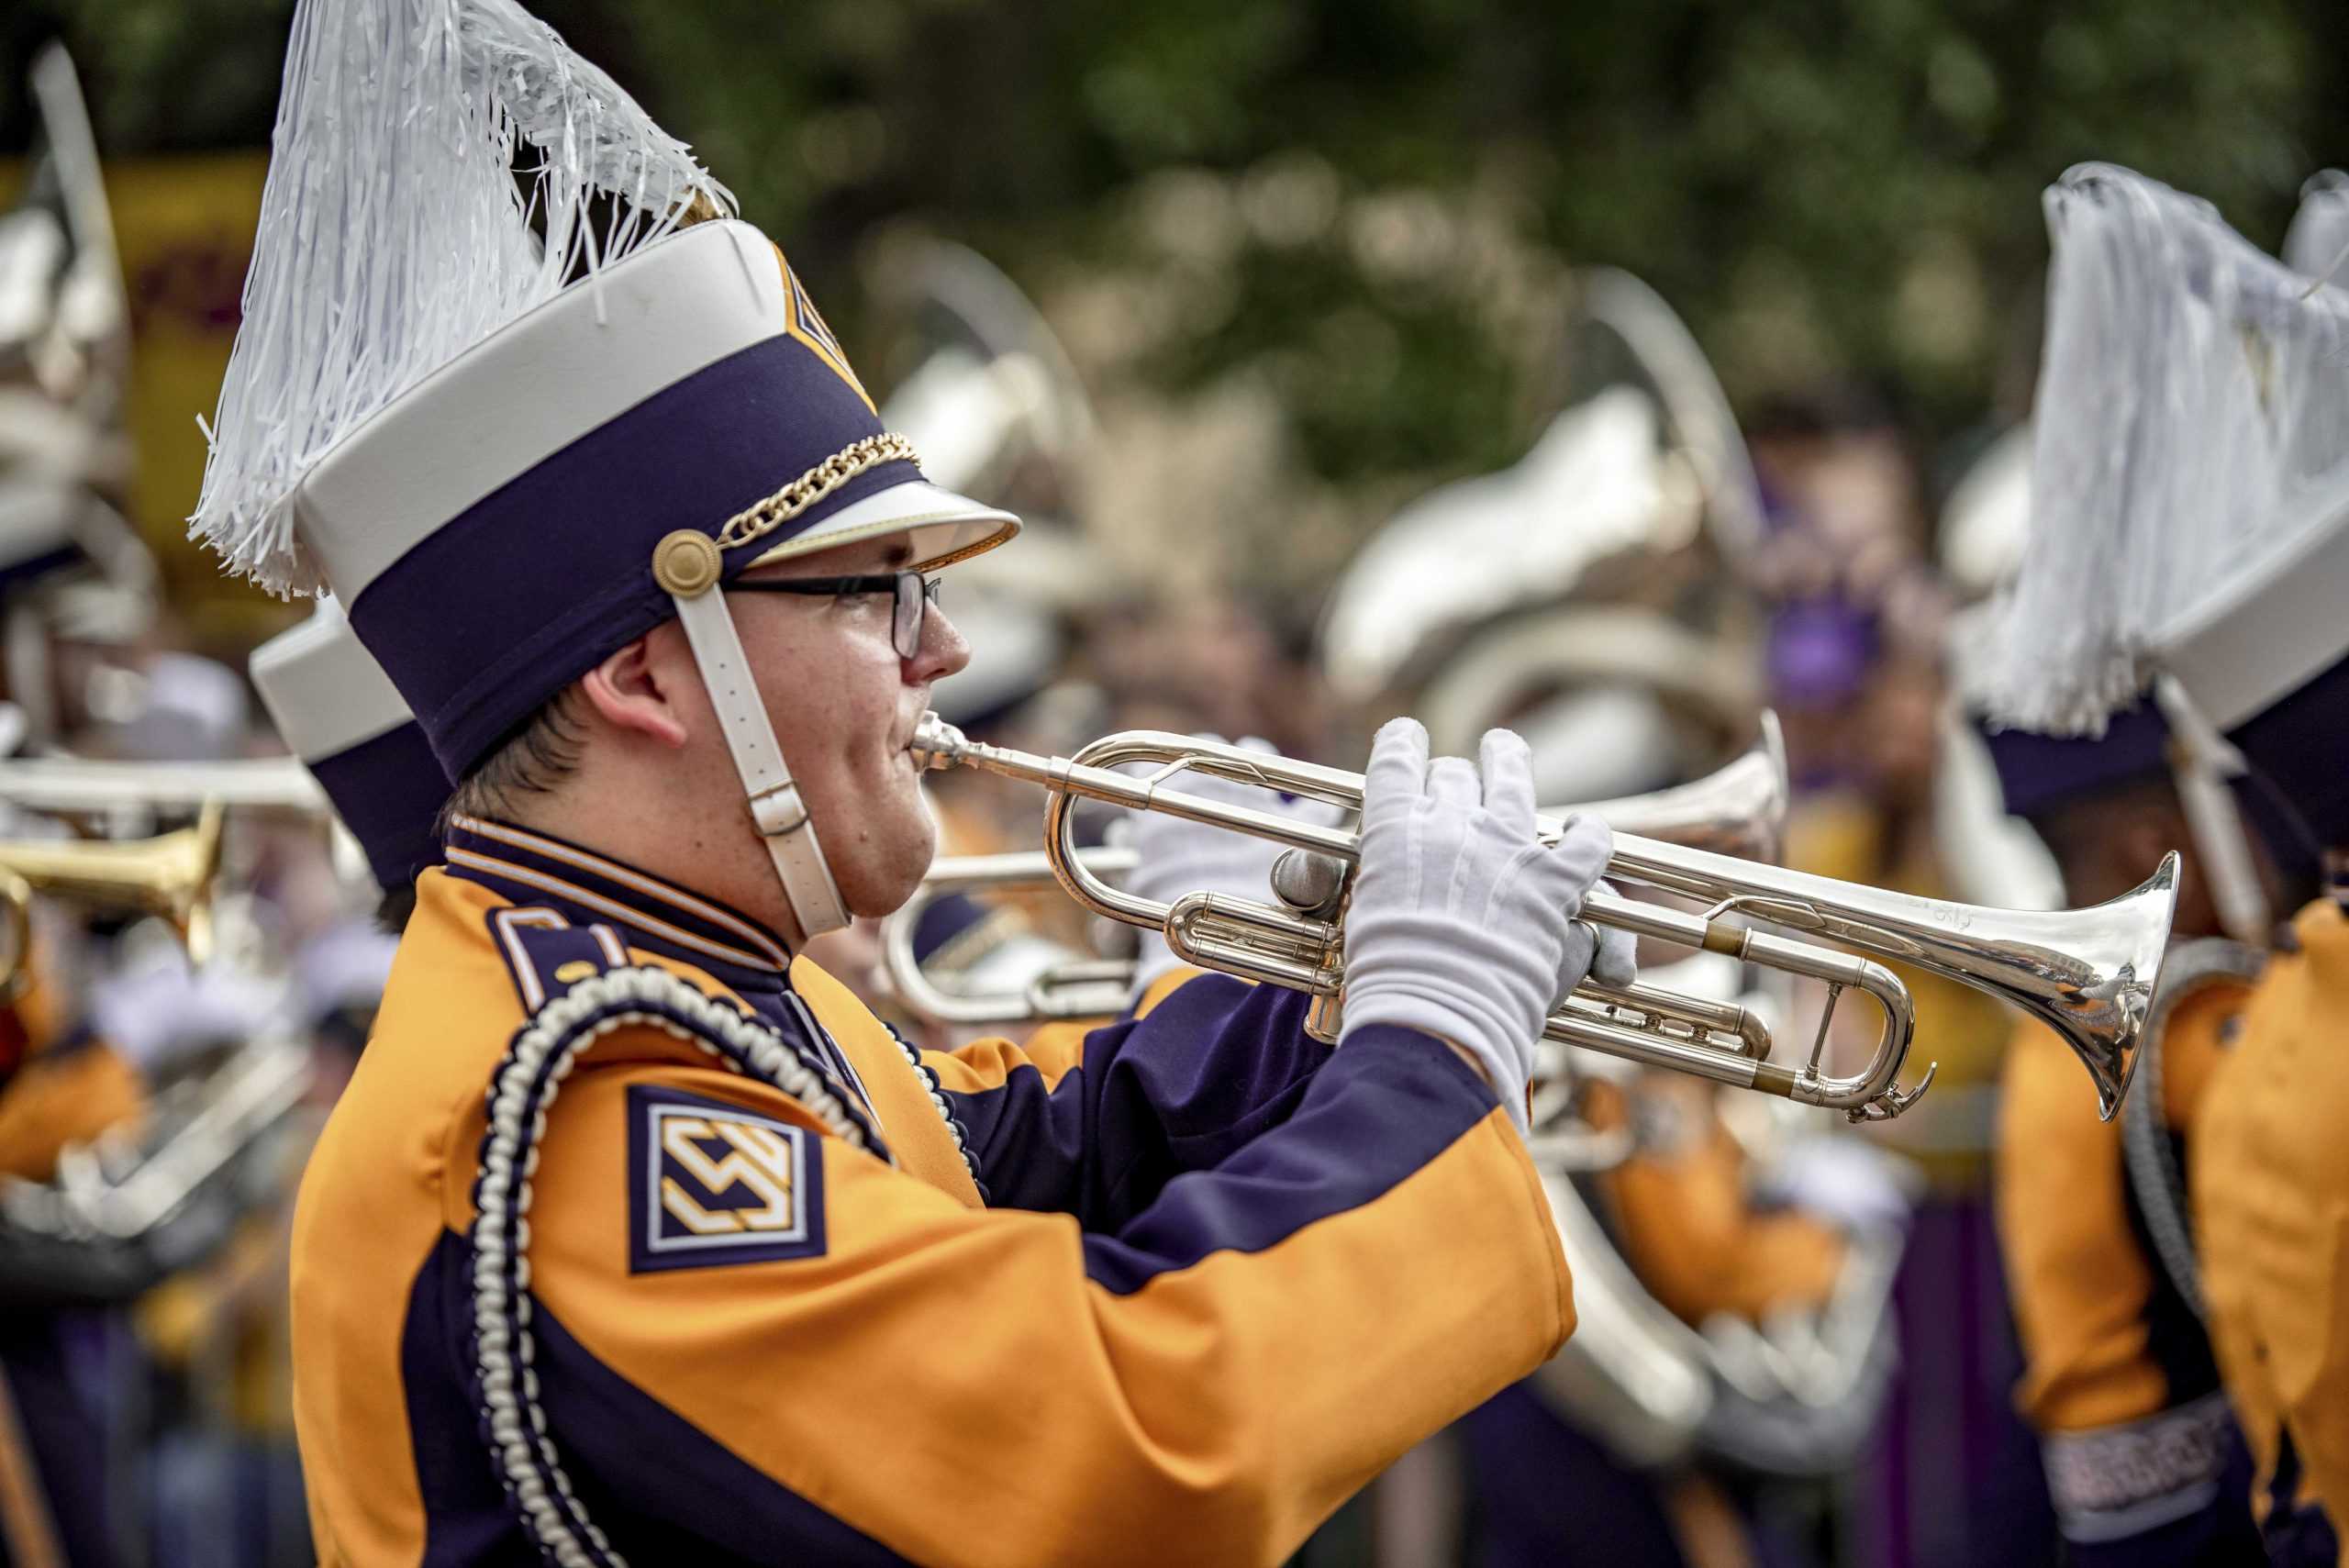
[1997,981,2257,1565]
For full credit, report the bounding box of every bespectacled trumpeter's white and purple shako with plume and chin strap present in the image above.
[193,0,1017,937]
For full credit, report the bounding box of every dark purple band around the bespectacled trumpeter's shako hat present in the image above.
[350,336,921,779]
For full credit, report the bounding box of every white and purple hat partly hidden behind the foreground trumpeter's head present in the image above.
[247,598,449,892]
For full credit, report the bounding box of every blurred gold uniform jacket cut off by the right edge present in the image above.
[2189,899,2349,1568]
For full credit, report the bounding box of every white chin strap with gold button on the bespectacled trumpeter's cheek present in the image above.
[653,533,848,937]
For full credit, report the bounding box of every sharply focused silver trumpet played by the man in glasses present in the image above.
[909,714,2177,1122]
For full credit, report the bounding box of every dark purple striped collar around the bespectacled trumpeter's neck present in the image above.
[446,817,792,991]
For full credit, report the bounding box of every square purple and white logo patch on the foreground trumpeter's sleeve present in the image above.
[628,1084,825,1274]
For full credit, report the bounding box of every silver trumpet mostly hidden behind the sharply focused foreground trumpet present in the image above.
[881,728,1787,1050]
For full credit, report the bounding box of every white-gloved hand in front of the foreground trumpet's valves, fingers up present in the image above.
[1341,718,1635,1131]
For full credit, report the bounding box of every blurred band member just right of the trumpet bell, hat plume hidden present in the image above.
[1989,699,2262,1568]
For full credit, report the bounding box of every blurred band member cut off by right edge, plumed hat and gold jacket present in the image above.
[1971,164,2349,1565]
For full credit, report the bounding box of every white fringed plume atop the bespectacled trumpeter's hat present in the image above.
[188,0,733,594]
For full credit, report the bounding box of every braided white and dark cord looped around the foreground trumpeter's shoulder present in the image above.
[473,967,874,1568]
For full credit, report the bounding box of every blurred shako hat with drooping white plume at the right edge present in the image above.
[1968,164,2349,868]
